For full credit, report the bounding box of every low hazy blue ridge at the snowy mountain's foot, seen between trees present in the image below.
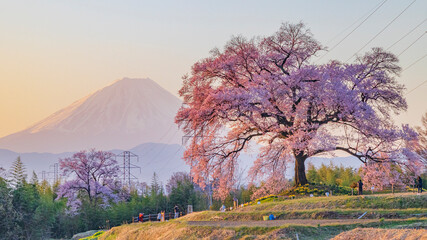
[0,146,361,184]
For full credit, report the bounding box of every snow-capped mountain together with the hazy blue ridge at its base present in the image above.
[0,78,360,182]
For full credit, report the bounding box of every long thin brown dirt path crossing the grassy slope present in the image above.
[188,219,387,227]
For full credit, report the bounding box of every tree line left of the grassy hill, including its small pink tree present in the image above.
[0,154,251,239]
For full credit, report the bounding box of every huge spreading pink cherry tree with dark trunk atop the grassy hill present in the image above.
[175,23,422,197]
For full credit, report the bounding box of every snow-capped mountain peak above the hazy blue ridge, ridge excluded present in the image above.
[0,78,182,153]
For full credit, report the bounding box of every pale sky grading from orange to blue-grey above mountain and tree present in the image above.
[0,0,427,137]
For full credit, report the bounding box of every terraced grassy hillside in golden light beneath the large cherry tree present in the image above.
[99,193,427,240]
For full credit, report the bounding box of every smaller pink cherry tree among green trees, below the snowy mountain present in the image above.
[58,149,120,212]
